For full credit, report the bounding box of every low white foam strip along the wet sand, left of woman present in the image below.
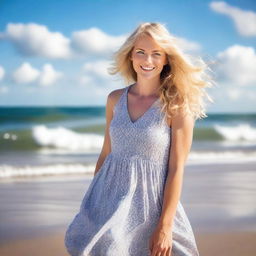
[0,164,95,179]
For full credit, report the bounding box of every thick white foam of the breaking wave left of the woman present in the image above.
[32,125,104,152]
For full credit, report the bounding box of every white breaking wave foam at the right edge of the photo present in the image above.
[214,124,256,141]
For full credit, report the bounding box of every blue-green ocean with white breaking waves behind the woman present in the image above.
[0,107,256,181]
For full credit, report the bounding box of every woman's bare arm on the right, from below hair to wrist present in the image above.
[158,109,194,229]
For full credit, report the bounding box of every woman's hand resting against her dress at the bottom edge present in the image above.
[149,226,172,256]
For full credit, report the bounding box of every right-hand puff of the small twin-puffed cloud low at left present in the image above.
[39,64,63,86]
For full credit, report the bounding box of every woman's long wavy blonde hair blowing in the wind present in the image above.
[108,22,213,119]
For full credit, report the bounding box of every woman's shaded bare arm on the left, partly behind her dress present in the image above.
[94,92,113,176]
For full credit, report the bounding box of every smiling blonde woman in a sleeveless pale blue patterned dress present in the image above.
[65,23,211,256]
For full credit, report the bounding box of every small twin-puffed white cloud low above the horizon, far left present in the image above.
[12,62,63,86]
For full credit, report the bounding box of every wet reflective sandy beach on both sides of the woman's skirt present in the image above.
[0,162,256,256]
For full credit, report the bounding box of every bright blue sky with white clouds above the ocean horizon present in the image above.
[0,0,256,113]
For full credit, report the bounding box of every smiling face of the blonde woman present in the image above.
[130,35,168,79]
